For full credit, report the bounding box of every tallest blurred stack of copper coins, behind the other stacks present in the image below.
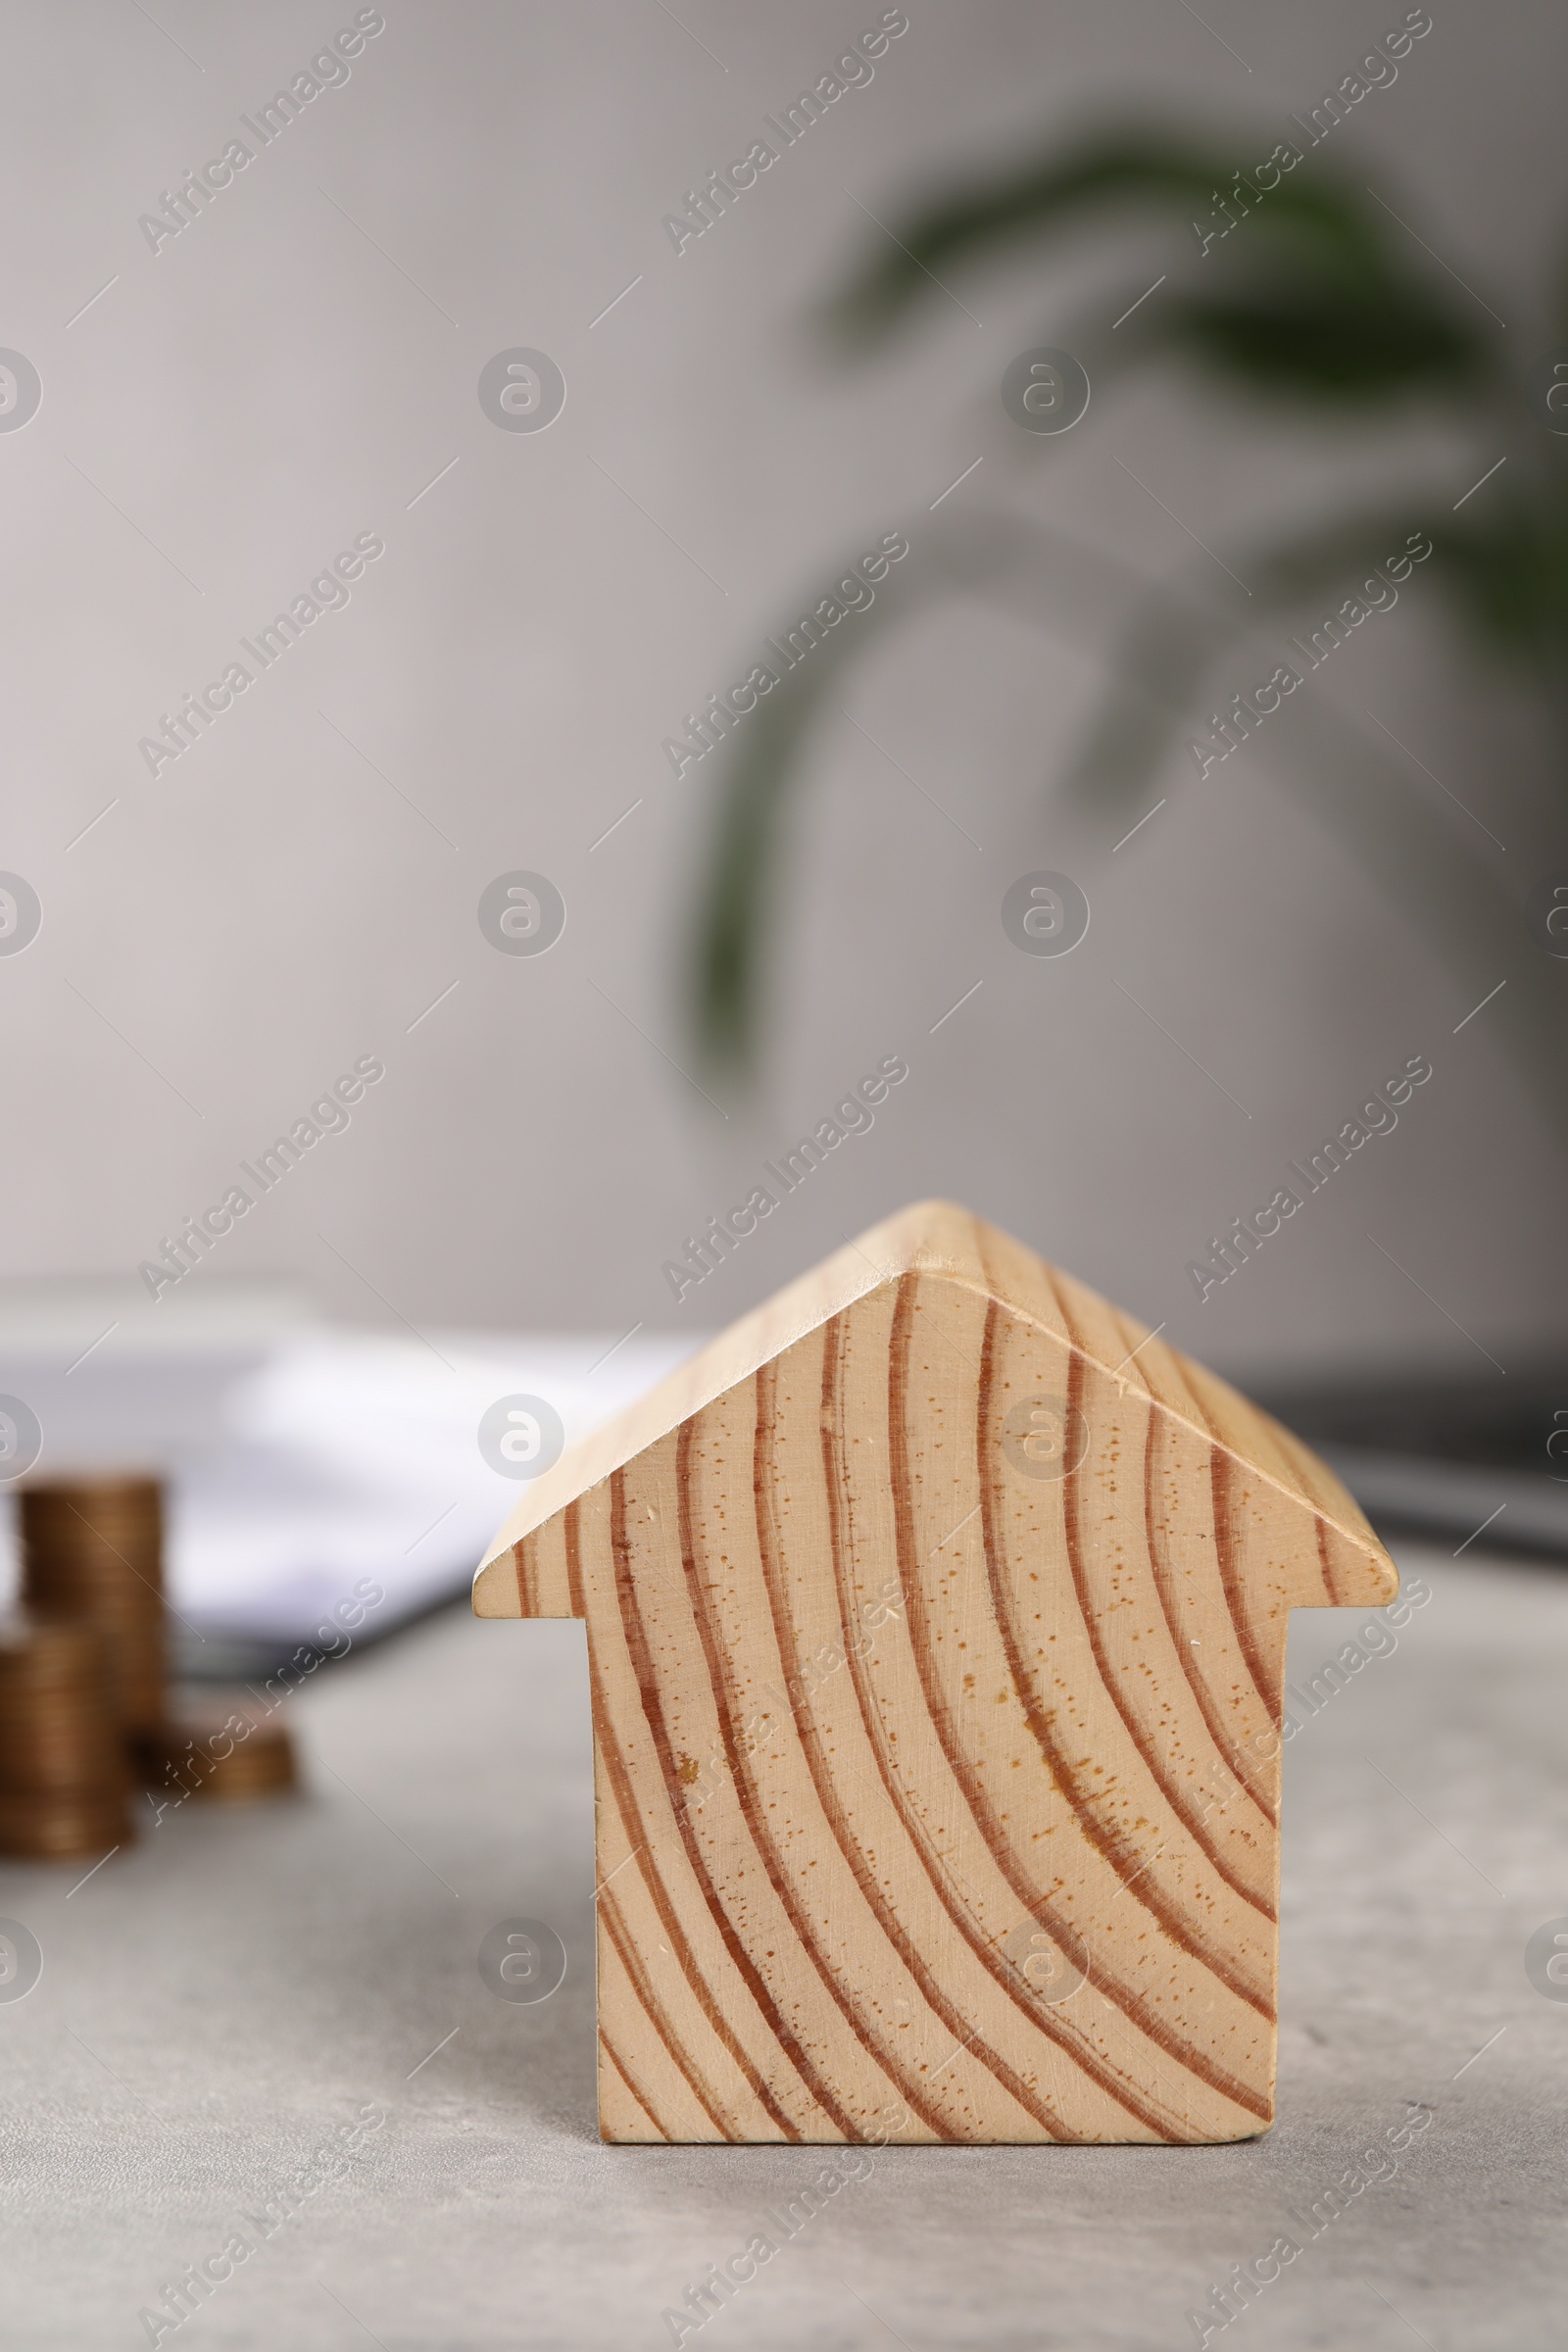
[22,1477,165,1731]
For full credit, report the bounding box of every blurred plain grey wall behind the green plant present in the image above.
[0,0,1568,1369]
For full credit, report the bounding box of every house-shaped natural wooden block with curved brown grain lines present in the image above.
[475,1201,1396,2142]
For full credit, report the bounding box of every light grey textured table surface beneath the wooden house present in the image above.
[0,1545,1568,2352]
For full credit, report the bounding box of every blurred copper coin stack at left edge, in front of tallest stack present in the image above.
[0,1616,134,1860]
